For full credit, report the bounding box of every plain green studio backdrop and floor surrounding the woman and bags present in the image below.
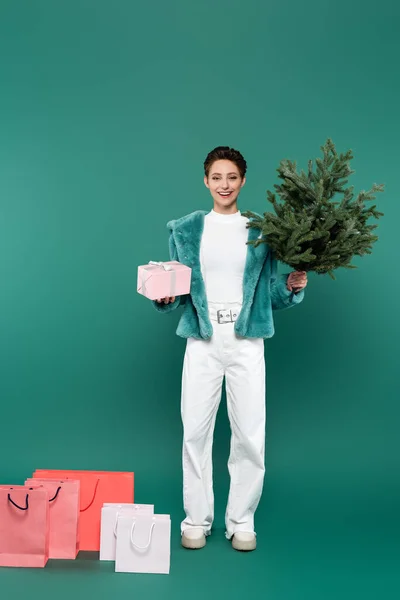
[0,0,400,600]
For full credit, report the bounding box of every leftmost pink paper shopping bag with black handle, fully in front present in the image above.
[0,485,49,567]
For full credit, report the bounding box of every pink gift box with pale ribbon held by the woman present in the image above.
[137,260,192,300]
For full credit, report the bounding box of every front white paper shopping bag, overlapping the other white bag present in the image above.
[115,513,171,574]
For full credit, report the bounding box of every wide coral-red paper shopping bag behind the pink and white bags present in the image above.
[33,469,134,551]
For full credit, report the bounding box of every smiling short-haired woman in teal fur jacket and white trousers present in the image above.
[154,146,307,551]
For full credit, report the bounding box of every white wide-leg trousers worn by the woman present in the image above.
[181,304,266,539]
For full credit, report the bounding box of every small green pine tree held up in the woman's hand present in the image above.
[243,139,384,279]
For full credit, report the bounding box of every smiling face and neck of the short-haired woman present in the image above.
[204,160,246,213]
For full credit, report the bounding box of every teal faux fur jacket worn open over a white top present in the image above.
[153,210,304,340]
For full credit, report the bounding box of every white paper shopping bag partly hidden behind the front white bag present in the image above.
[100,502,154,560]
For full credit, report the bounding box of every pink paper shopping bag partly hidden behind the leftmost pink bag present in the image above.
[25,479,80,559]
